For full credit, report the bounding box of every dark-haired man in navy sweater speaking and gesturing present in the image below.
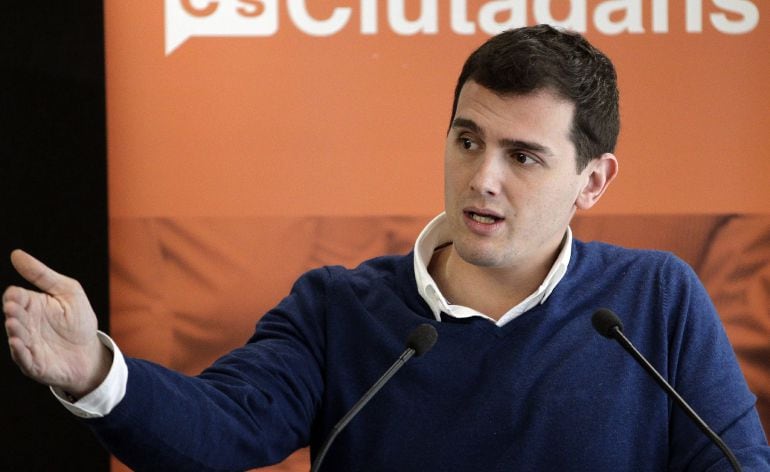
[3,26,770,471]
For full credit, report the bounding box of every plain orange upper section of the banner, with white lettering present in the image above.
[105,0,770,217]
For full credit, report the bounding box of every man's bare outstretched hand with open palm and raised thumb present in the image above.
[3,249,112,397]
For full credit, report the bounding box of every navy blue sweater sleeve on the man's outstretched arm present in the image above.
[85,269,330,471]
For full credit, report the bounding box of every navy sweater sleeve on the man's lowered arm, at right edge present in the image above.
[660,257,770,471]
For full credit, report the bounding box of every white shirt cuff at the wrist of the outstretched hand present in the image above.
[50,331,128,418]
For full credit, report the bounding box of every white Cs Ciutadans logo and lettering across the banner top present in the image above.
[164,0,759,55]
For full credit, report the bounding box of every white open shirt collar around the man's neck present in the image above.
[414,213,572,326]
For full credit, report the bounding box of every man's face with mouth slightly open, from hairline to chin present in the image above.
[444,81,593,269]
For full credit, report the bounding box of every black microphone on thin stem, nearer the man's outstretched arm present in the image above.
[310,323,438,472]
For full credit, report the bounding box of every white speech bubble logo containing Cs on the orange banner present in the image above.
[164,0,278,56]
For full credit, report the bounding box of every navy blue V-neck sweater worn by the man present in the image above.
[87,241,770,472]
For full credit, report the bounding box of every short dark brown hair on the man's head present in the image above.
[450,25,620,172]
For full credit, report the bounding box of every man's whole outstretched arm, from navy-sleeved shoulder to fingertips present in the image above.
[3,251,328,471]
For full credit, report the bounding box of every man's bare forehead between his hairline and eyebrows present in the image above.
[455,81,575,141]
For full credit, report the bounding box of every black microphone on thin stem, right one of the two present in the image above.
[591,308,741,472]
